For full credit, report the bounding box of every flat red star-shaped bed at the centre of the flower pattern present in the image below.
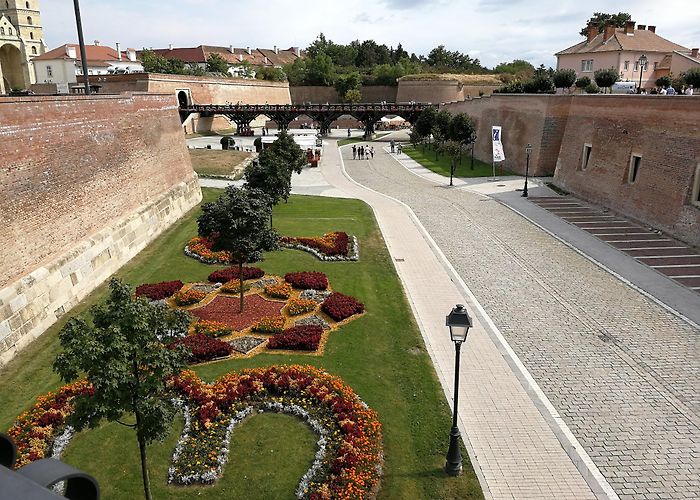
[189,294,284,331]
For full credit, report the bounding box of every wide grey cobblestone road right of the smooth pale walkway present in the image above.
[343,144,700,499]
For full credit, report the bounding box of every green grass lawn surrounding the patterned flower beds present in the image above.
[0,190,482,499]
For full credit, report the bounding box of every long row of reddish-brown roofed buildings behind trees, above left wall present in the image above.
[145,45,303,76]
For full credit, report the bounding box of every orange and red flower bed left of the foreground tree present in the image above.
[8,380,92,468]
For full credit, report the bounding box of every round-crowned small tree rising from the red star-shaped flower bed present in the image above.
[197,186,277,312]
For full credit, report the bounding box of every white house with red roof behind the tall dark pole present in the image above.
[33,41,143,85]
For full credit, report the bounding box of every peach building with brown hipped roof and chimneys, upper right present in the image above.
[555,21,700,89]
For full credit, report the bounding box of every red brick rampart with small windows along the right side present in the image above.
[445,94,700,246]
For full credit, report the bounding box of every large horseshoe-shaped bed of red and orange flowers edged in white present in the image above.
[168,366,382,500]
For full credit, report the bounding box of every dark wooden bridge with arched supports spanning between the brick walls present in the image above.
[180,103,431,136]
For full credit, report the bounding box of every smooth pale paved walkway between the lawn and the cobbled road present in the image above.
[321,142,600,499]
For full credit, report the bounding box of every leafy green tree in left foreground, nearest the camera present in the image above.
[53,279,190,500]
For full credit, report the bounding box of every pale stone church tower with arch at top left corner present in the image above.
[0,0,46,94]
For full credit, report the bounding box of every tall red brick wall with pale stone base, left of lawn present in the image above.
[0,94,201,364]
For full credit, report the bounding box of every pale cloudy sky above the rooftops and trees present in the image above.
[40,0,700,67]
